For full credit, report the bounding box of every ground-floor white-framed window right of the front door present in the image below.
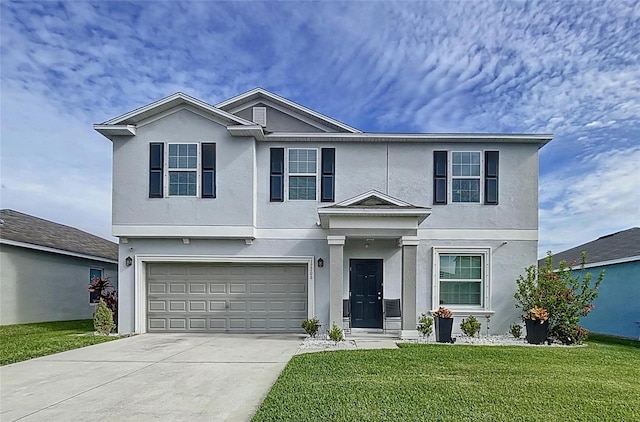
[431,247,491,311]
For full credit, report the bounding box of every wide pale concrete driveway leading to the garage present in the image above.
[0,334,302,422]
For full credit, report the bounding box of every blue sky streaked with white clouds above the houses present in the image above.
[0,1,640,255]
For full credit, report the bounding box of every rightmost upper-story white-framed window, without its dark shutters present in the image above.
[449,151,483,204]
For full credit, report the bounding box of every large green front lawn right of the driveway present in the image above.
[253,342,640,422]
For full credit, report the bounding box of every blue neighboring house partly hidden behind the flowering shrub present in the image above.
[538,227,640,339]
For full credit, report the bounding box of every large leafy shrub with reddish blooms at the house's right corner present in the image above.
[514,252,604,344]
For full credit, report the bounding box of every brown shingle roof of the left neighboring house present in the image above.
[0,209,118,260]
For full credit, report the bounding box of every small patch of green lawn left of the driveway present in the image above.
[0,319,117,365]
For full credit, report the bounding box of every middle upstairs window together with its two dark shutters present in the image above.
[269,148,336,202]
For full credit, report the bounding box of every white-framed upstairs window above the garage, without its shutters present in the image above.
[166,143,200,196]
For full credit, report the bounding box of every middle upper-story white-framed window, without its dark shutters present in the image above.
[287,148,318,201]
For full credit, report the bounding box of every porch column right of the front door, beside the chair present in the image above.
[400,236,420,338]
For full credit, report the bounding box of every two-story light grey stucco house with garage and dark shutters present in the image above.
[94,88,552,337]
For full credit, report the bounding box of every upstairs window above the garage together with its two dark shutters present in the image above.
[149,142,216,198]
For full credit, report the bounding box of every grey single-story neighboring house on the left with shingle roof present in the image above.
[0,209,118,325]
